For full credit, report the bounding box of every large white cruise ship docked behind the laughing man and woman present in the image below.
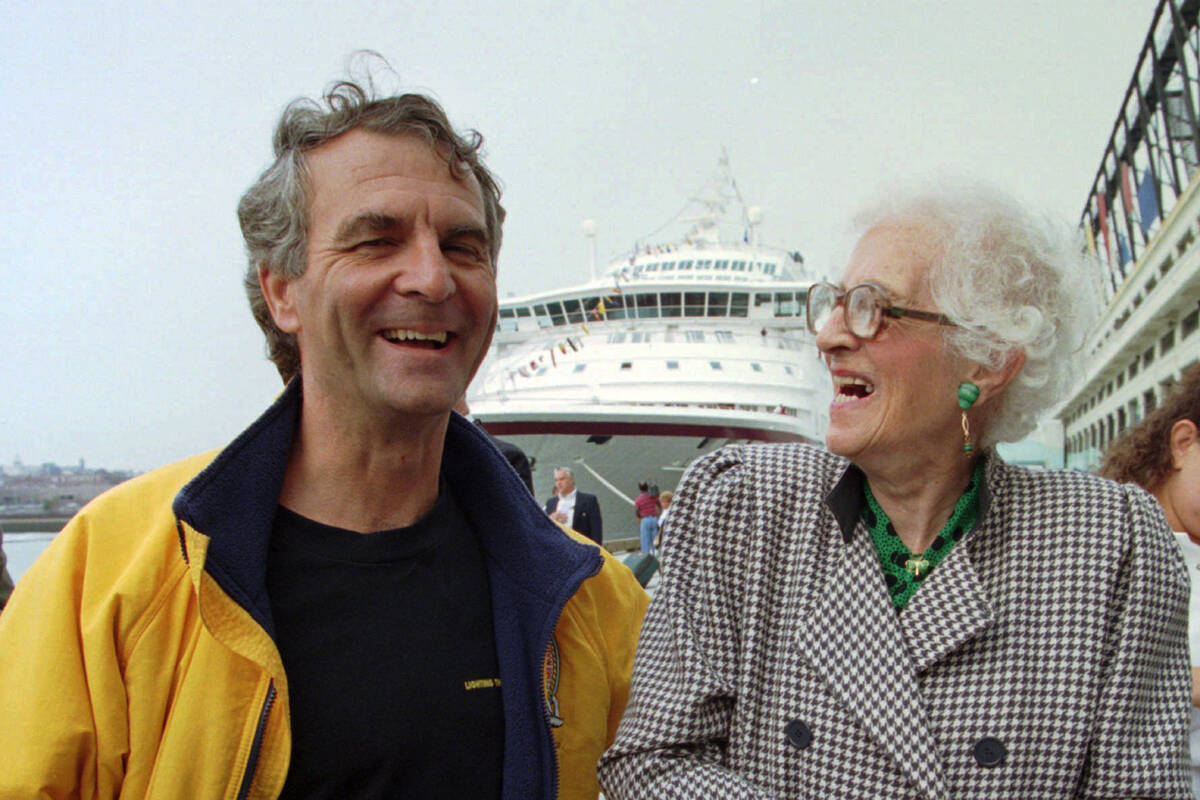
[468,154,829,539]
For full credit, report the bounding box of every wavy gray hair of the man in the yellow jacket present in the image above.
[238,80,504,381]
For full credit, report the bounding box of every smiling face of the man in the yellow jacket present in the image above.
[263,130,497,422]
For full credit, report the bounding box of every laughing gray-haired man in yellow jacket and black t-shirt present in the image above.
[0,70,647,800]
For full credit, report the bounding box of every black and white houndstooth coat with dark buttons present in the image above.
[600,445,1192,800]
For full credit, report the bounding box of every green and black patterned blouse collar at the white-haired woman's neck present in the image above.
[863,458,984,610]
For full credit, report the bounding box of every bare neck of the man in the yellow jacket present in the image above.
[280,388,450,534]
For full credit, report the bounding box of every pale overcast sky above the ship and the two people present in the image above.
[0,0,1157,470]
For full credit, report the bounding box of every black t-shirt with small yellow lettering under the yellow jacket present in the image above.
[266,483,504,800]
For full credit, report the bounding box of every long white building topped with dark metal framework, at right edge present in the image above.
[1058,0,1200,470]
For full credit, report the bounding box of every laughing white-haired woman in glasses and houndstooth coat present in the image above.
[600,187,1189,800]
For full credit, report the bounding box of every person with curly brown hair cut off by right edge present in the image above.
[1100,366,1200,798]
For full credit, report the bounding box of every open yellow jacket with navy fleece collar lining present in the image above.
[0,381,647,800]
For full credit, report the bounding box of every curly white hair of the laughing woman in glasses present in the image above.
[854,181,1099,447]
